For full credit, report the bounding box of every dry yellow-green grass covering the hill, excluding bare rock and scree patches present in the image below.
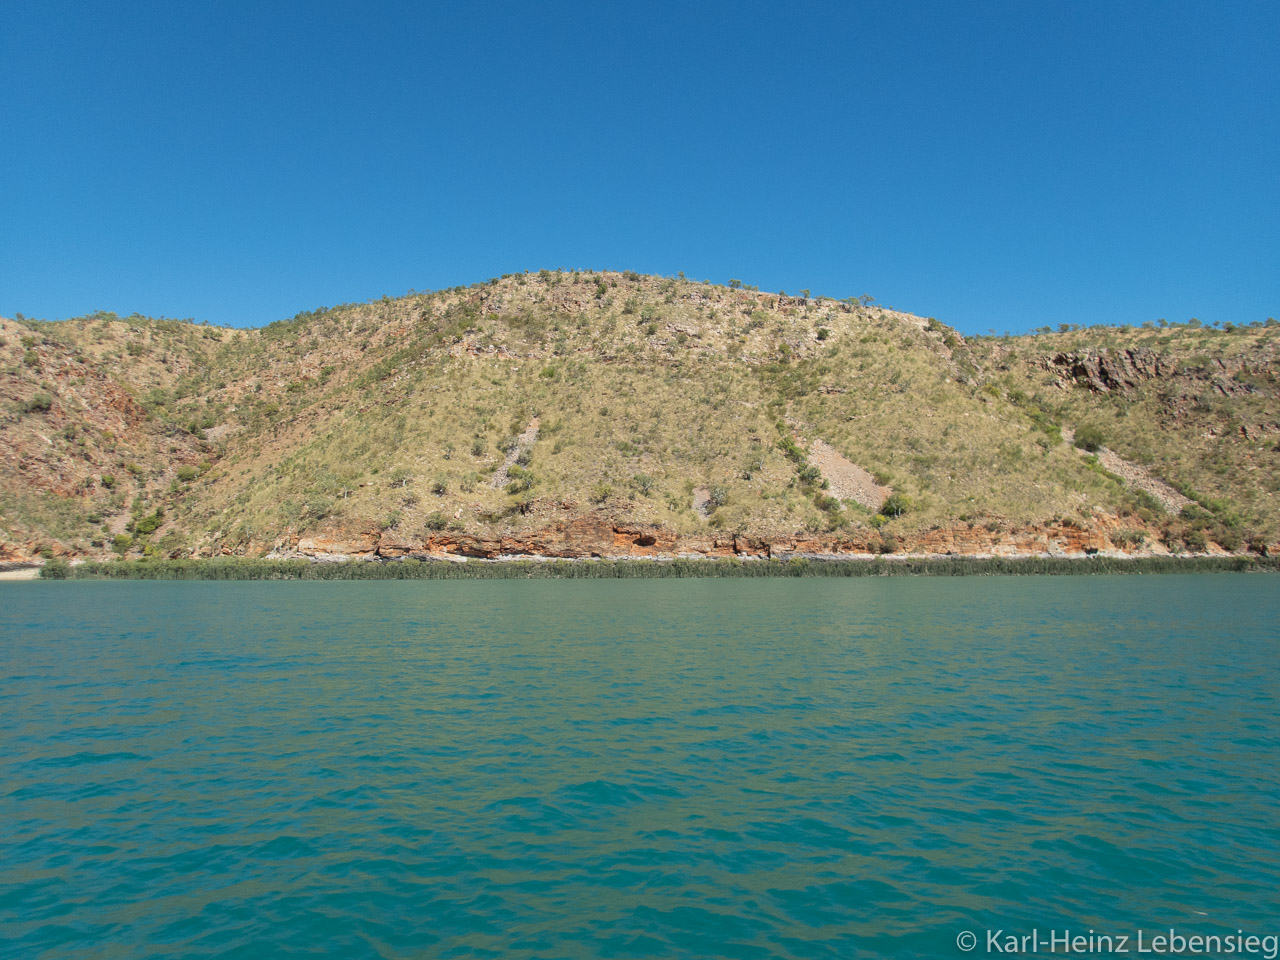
[0,273,1280,553]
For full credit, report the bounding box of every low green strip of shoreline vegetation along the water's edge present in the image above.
[38,556,1280,580]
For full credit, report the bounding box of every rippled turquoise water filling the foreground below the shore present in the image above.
[0,575,1280,960]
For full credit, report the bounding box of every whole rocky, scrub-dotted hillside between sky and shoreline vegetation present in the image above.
[0,271,1280,561]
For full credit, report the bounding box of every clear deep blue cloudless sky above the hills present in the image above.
[0,0,1280,332]
